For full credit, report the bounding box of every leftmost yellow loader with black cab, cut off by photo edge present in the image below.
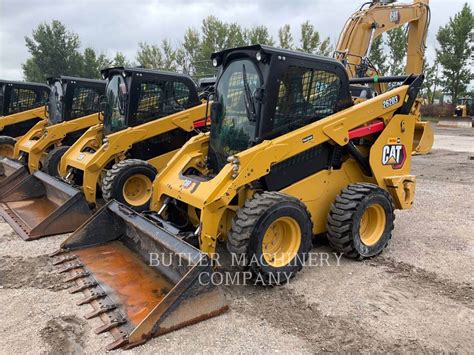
[0,80,50,159]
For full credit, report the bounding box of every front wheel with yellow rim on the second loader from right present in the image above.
[102,159,157,212]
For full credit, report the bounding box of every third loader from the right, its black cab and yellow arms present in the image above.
[13,76,105,176]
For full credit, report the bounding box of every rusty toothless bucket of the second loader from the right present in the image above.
[0,171,91,240]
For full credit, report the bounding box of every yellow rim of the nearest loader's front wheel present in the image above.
[262,217,301,267]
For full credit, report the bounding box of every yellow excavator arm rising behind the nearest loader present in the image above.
[335,0,430,78]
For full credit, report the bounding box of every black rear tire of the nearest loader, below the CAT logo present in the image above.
[326,183,395,260]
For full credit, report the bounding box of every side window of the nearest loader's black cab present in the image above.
[273,66,341,131]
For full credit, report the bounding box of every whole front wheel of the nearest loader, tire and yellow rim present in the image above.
[227,192,312,285]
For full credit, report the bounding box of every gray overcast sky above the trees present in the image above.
[0,0,473,79]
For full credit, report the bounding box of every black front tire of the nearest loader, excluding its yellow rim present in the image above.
[227,192,313,286]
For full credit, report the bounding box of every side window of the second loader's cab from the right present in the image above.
[134,82,165,126]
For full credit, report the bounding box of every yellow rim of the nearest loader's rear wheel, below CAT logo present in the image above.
[359,204,386,246]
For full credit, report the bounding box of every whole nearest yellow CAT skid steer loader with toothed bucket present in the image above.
[52,45,423,346]
